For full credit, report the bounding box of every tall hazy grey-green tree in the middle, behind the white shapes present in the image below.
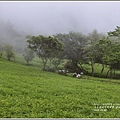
[54,32,87,72]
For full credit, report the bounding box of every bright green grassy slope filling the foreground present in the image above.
[0,59,120,118]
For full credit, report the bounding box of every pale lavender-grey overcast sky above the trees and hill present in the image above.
[0,1,120,35]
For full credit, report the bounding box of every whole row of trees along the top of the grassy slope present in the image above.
[0,26,120,79]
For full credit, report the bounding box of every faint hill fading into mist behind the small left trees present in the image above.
[0,20,26,51]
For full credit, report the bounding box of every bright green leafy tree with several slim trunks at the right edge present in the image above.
[97,37,120,79]
